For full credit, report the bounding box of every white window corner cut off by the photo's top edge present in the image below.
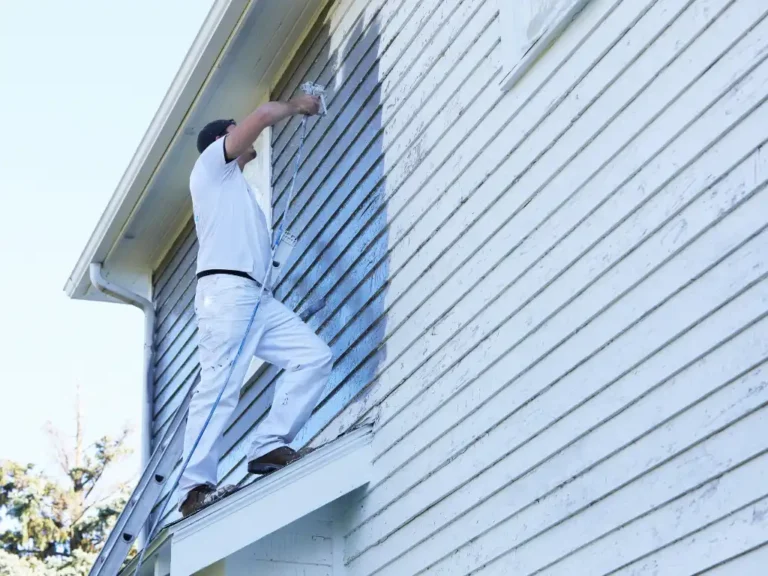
[497,0,589,90]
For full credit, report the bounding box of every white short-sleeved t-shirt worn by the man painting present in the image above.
[189,138,271,282]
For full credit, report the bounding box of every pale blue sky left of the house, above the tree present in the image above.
[0,0,213,486]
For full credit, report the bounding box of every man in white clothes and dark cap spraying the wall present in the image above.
[179,95,332,517]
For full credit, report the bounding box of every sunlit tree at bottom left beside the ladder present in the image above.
[0,394,130,576]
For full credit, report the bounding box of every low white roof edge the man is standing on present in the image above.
[122,425,373,576]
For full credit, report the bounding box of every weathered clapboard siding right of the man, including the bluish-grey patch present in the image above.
[266,0,768,575]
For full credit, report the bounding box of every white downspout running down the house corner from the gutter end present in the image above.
[90,262,155,536]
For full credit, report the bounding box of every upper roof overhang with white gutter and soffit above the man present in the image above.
[65,0,325,299]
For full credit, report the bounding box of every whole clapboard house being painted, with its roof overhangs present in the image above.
[66,0,768,576]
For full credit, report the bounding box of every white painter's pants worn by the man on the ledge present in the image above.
[179,275,333,499]
